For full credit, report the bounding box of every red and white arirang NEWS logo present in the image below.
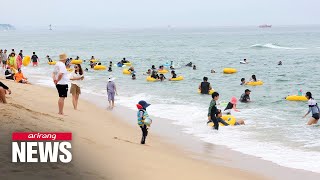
[12,132,72,163]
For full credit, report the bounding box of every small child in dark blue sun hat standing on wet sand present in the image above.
[137,100,152,144]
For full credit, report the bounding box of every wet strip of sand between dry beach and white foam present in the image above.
[77,83,320,180]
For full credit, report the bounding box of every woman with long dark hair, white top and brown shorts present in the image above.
[70,64,84,110]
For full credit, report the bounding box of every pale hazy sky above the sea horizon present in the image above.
[0,0,320,28]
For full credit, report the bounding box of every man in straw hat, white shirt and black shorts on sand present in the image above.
[52,53,69,115]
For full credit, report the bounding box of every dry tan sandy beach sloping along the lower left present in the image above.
[0,80,265,180]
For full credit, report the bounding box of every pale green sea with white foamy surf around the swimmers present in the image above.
[0,26,320,172]
